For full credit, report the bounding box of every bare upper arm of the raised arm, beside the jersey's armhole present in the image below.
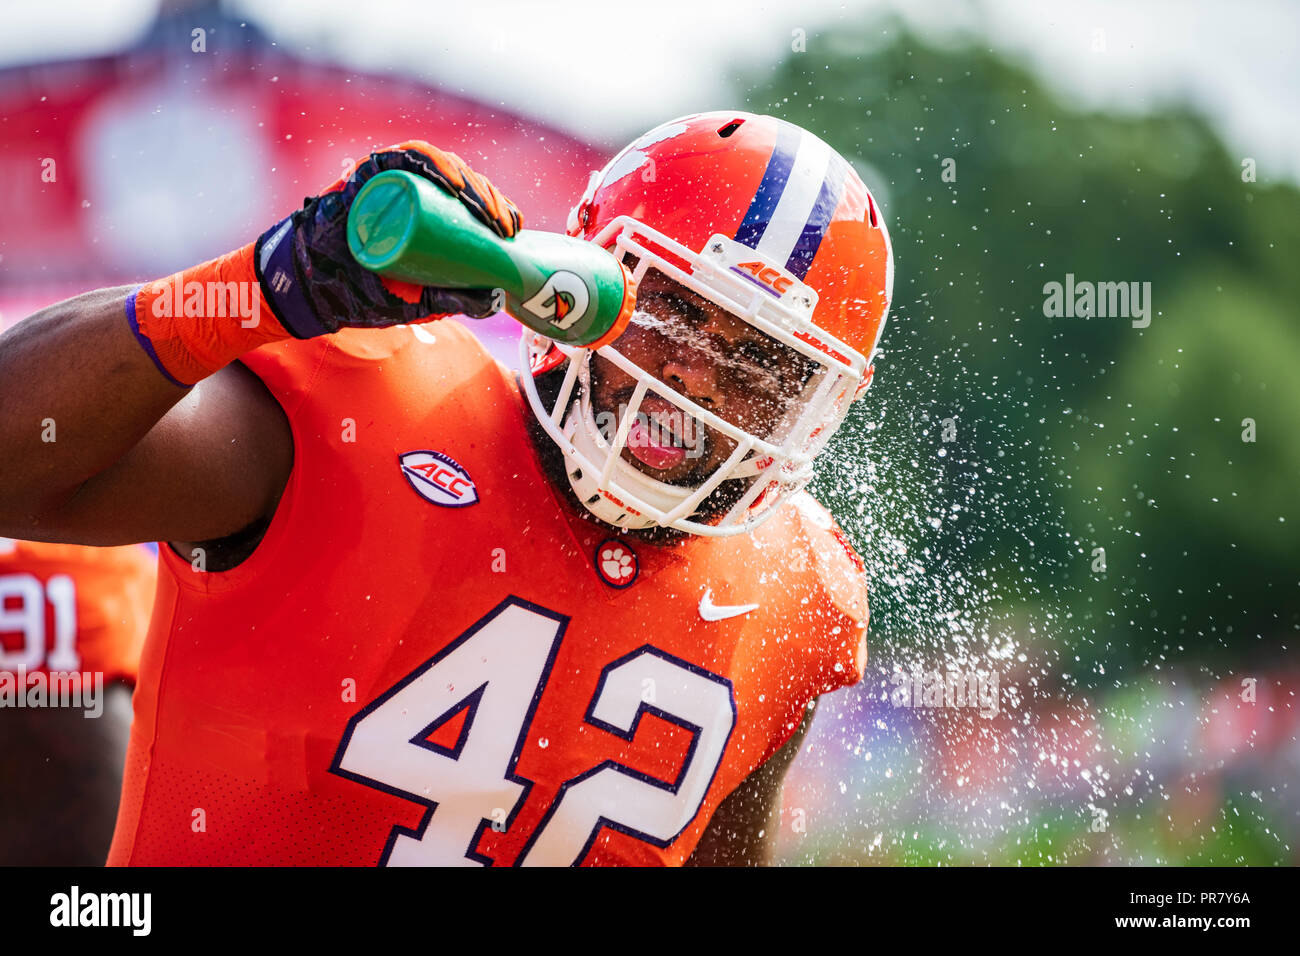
[46,363,294,545]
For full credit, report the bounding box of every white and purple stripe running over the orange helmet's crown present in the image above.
[736,121,849,278]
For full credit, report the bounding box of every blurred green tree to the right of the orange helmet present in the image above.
[742,21,1300,683]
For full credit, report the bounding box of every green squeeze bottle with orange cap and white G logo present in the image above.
[347,169,636,349]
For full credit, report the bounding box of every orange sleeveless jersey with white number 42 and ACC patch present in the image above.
[109,321,866,865]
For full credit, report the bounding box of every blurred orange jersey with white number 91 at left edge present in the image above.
[0,537,157,683]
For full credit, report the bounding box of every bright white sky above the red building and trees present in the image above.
[0,0,1300,181]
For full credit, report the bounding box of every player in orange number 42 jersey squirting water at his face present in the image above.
[0,113,892,865]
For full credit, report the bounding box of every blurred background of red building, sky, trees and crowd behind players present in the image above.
[0,3,1300,865]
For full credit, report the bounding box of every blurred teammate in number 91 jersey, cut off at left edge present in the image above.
[0,538,157,866]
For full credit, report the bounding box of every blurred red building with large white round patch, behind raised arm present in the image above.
[0,3,606,364]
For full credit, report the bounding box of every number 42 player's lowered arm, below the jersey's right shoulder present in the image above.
[686,709,813,866]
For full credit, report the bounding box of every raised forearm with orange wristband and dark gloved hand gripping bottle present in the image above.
[0,142,521,540]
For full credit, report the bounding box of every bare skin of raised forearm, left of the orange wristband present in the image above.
[0,286,187,537]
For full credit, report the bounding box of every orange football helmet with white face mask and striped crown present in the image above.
[520,112,893,536]
